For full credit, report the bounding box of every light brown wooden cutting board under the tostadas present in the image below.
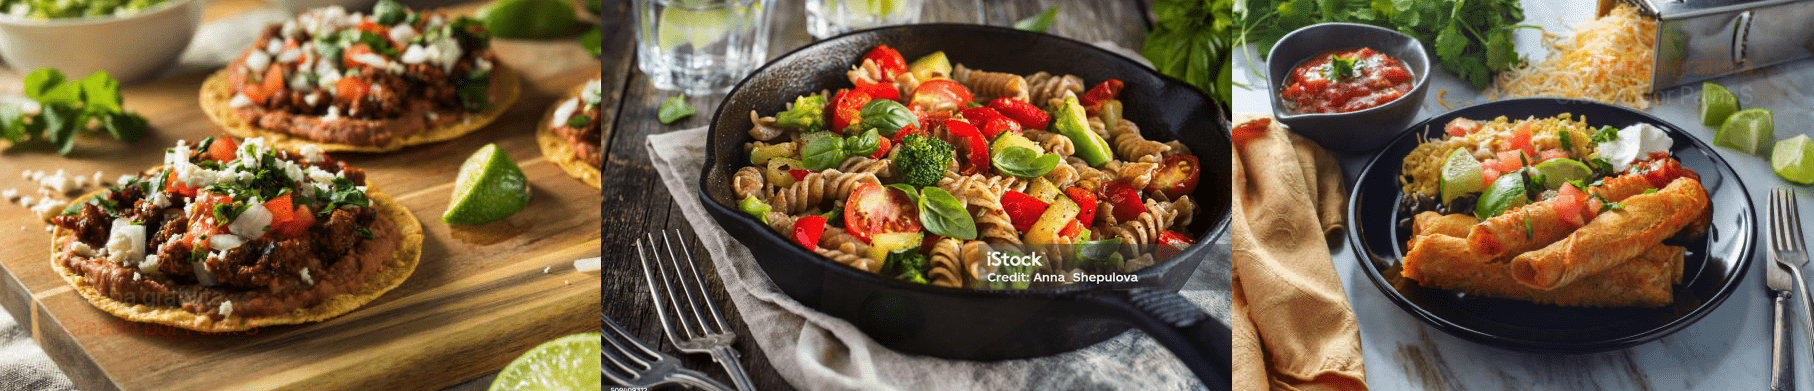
[0,4,600,389]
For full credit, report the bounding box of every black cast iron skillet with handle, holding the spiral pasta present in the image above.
[698,24,1230,389]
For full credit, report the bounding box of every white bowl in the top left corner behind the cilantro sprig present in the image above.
[0,0,203,83]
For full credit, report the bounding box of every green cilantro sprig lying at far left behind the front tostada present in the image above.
[0,69,147,156]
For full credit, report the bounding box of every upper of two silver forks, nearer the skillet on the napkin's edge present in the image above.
[637,230,755,391]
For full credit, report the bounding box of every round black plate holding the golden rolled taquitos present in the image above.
[1348,98,1756,353]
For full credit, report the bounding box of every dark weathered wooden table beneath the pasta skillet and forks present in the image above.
[600,0,1152,389]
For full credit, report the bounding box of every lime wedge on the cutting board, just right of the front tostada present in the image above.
[441,145,530,224]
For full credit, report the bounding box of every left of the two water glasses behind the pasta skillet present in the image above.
[635,0,775,96]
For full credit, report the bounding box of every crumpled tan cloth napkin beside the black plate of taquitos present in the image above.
[1232,114,1366,389]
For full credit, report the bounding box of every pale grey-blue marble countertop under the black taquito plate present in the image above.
[1234,0,1814,391]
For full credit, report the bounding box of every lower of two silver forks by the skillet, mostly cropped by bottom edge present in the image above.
[599,313,731,391]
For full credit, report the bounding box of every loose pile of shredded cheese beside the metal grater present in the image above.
[1487,4,1656,109]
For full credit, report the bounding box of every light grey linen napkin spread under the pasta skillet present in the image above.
[648,129,1230,391]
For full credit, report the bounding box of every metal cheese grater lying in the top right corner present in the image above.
[1600,0,1814,91]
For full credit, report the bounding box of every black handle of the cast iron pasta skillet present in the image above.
[1085,288,1234,389]
